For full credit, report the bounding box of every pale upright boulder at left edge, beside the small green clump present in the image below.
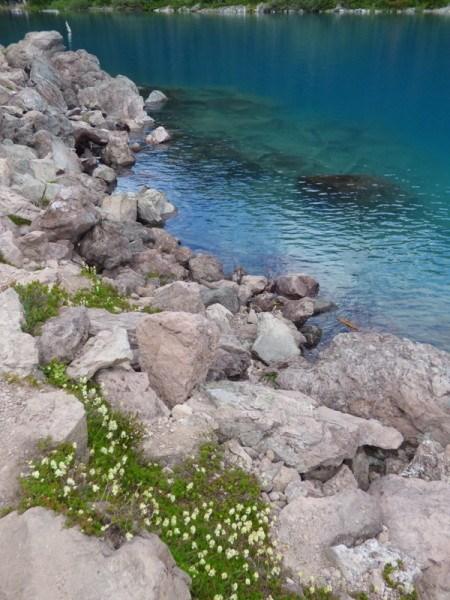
[0,288,39,377]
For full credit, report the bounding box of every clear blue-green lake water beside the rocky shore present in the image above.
[0,13,450,350]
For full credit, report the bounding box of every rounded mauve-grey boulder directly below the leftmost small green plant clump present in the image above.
[38,306,89,364]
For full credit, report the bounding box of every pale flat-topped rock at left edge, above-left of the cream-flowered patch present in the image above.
[0,381,87,506]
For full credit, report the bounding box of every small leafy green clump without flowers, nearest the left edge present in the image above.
[14,281,68,335]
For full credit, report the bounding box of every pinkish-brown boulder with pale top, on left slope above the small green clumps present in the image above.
[31,194,100,242]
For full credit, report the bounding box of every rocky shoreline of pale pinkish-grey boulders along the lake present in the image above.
[0,32,450,600]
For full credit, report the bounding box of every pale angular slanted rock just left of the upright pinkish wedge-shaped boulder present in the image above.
[67,327,133,379]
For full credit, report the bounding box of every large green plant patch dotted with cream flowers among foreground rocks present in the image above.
[21,361,294,600]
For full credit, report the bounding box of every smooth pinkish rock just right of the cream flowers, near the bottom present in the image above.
[273,490,382,581]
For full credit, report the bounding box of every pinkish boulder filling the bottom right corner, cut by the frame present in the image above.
[370,475,450,600]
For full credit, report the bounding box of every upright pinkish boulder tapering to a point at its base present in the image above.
[136,312,219,406]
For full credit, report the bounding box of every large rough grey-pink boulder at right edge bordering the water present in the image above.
[278,332,450,446]
